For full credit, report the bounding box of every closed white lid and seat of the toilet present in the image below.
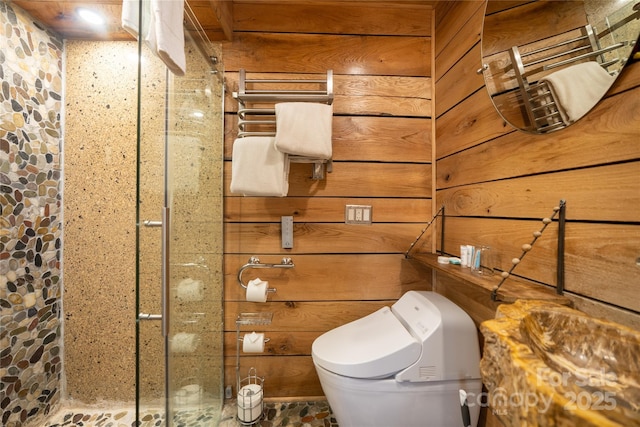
[311,307,422,378]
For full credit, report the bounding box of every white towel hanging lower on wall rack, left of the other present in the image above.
[231,136,289,197]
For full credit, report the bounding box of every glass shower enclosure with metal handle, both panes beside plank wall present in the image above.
[136,3,224,426]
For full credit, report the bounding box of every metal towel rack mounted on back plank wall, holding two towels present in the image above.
[233,68,333,180]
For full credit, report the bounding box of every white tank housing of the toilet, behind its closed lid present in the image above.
[391,291,480,382]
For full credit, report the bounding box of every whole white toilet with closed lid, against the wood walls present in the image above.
[312,291,482,427]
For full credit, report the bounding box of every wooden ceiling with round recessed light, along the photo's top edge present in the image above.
[11,0,438,41]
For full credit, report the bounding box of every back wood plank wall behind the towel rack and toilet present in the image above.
[223,1,432,397]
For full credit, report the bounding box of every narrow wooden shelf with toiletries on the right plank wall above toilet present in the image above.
[411,253,570,305]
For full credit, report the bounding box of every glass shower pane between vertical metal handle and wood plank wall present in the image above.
[165,47,223,425]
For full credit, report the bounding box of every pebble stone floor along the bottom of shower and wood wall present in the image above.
[44,401,338,427]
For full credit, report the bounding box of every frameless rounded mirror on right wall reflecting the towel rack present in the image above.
[478,0,640,133]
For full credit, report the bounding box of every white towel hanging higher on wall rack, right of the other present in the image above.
[276,102,333,159]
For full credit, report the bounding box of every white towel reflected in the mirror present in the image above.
[541,61,615,125]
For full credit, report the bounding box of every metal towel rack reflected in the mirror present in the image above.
[509,25,627,132]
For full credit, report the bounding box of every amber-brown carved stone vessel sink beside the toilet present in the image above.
[480,300,640,427]
